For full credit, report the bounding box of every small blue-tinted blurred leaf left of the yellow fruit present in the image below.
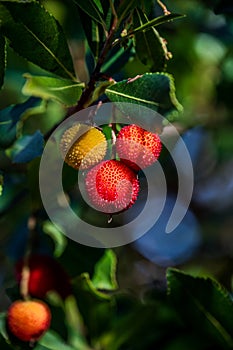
[9,131,44,163]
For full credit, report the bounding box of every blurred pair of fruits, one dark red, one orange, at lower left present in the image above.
[6,255,72,342]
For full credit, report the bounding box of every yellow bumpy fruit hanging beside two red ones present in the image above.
[60,124,107,169]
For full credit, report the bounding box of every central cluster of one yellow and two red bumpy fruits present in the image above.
[60,123,162,214]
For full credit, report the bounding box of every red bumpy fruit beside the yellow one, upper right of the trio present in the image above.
[116,124,162,171]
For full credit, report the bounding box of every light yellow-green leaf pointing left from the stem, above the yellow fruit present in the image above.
[22,74,84,107]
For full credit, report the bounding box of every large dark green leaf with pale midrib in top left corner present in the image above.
[0,0,75,80]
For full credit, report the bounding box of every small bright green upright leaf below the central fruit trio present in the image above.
[92,249,117,290]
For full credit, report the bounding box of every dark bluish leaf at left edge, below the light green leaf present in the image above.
[0,98,41,149]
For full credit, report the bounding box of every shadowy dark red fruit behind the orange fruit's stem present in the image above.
[16,254,72,299]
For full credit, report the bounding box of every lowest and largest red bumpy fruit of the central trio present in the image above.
[85,160,139,214]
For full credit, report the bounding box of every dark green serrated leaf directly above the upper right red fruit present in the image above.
[106,73,182,122]
